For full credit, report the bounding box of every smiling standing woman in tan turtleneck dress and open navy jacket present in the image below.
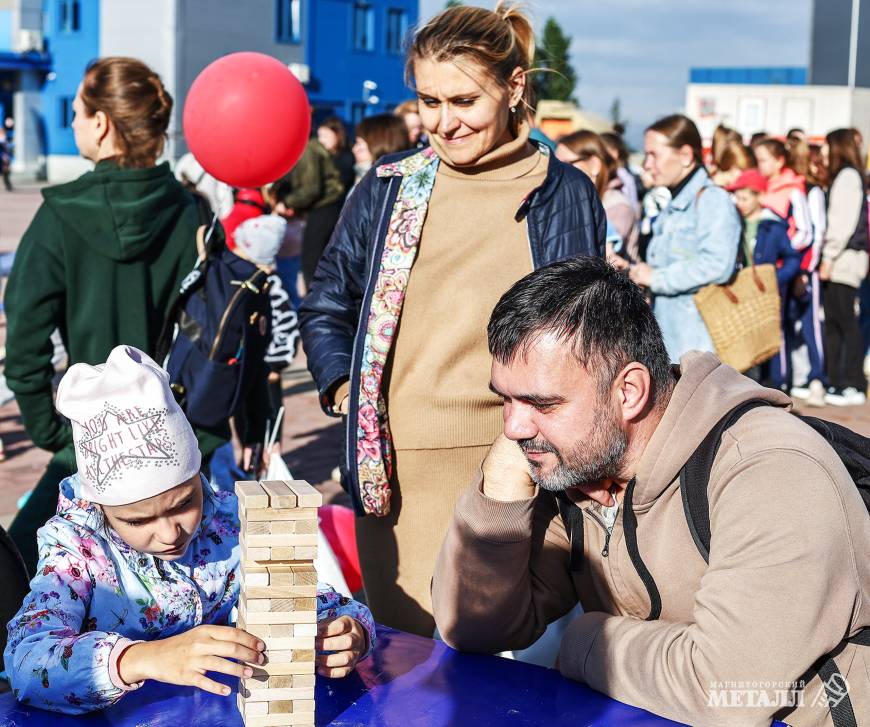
[301,3,606,636]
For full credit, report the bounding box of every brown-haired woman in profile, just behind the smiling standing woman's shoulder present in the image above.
[556,130,639,262]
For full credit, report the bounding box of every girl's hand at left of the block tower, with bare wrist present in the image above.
[118,626,266,696]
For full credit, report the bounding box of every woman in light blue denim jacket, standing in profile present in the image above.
[629,114,741,361]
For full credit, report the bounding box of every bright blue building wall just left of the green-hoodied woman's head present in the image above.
[42,0,100,155]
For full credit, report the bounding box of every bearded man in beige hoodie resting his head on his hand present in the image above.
[433,258,870,726]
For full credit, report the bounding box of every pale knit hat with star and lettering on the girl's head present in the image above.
[56,346,201,505]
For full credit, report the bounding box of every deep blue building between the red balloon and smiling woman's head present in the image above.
[305,0,419,124]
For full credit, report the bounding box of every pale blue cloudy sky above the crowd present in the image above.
[420,0,812,144]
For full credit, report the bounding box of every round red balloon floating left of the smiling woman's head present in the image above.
[184,53,311,187]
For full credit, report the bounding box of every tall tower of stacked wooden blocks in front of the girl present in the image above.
[236,480,323,727]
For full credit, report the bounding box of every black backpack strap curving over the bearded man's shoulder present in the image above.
[680,399,768,563]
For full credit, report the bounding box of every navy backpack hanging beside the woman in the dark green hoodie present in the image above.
[157,212,272,427]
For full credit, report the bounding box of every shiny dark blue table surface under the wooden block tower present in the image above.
[0,627,708,727]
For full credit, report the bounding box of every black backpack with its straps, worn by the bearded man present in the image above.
[556,399,870,727]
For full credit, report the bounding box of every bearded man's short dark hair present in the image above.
[487,257,673,402]
